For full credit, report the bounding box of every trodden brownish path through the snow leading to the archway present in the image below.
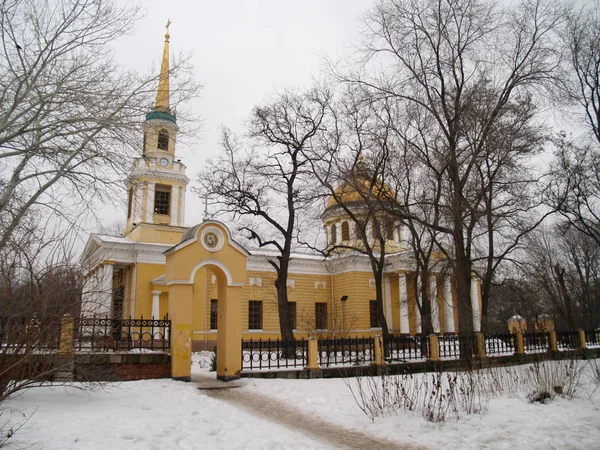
[194,378,425,450]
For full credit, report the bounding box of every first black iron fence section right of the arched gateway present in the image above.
[242,339,308,370]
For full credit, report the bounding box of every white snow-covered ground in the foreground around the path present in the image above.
[0,356,600,450]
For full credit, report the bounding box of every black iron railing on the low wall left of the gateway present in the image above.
[74,317,171,352]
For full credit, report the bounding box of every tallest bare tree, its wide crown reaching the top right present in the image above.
[337,0,564,334]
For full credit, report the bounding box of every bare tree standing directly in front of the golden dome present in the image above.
[307,91,396,352]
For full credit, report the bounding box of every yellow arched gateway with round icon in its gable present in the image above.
[165,221,248,381]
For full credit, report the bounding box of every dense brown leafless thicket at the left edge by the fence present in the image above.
[0,214,82,426]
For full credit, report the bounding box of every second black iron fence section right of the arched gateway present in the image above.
[317,337,374,367]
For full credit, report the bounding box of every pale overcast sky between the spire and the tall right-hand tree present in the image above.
[103,0,375,230]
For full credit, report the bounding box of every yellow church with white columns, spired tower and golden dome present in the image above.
[81,32,481,351]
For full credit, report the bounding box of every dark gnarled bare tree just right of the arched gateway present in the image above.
[197,89,328,350]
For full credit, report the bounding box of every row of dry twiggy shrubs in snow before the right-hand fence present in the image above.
[346,360,600,422]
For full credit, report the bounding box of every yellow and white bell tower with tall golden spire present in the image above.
[123,21,190,244]
